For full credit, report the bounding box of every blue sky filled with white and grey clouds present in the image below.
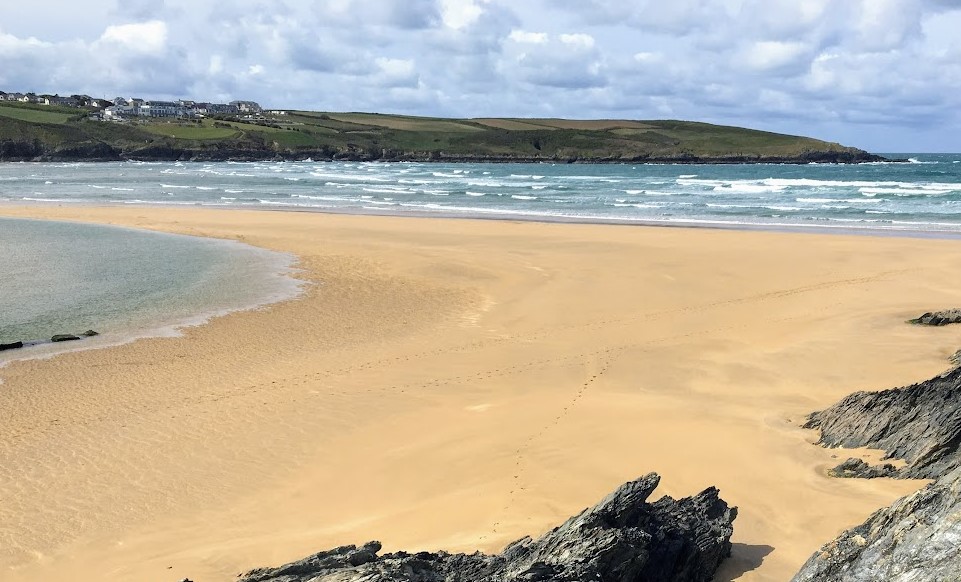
[0,0,961,152]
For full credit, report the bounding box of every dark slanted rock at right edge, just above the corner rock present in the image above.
[804,368,961,479]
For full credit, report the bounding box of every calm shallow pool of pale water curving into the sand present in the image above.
[0,218,296,363]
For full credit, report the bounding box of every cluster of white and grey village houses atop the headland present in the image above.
[0,91,262,121]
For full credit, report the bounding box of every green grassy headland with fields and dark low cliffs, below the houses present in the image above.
[0,103,876,163]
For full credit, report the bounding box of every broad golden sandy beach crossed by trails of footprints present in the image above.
[0,206,961,582]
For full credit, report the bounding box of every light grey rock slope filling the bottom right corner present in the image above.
[792,469,961,582]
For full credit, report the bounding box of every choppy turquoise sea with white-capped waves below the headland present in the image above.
[0,154,961,232]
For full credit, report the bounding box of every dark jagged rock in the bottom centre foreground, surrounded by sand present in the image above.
[239,473,737,582]
